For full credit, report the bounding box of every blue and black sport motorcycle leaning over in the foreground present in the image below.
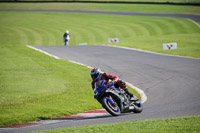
[94,80,143,116]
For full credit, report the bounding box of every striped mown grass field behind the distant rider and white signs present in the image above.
[0,12,200,57]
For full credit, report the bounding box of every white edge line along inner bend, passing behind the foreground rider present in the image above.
[26,45,147,103]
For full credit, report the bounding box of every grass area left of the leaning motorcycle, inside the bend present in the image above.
[0,46,101,126]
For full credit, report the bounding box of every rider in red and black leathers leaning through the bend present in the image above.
[90,68,139,101]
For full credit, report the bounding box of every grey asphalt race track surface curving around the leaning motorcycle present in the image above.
[0,10,200,133]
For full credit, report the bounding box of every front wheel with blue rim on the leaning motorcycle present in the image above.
[101,97,121,116]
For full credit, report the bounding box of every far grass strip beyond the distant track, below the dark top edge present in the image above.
[0,3,200,14]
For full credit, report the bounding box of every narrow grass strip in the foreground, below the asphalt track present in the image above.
[30,116,200,133]
